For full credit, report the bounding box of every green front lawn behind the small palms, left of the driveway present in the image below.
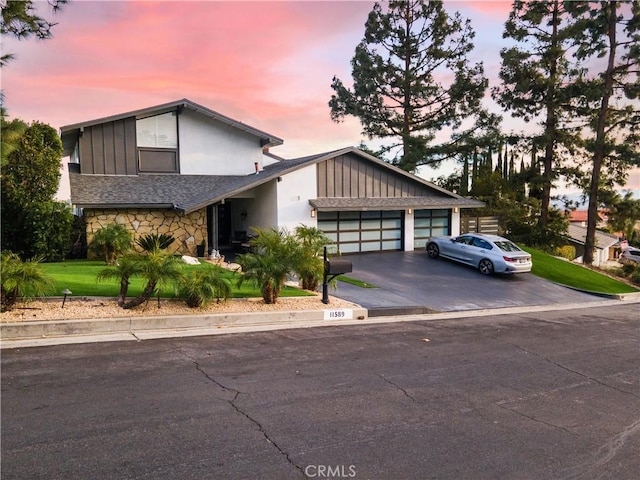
[42,260,312,298]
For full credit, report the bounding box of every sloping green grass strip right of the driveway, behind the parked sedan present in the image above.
[522,247,639,294]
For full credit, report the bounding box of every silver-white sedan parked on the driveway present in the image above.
[426,233,533,275]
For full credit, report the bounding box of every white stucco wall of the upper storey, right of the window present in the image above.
[178,109,263,175]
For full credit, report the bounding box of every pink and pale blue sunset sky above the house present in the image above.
[0,0,640,199]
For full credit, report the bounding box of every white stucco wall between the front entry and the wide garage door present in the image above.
[276,164,318,232]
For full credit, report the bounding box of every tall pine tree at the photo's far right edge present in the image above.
[576,0,640,265]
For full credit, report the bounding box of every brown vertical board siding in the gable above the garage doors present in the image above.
[318,154,440,198]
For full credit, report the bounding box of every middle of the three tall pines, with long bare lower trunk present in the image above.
[492,0,587,228]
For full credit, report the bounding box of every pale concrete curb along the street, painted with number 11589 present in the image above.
[0,294,640,349]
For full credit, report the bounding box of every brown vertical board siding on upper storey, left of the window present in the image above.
[79,117,137,175]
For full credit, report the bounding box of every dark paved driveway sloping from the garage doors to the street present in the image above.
[329,250,602,316]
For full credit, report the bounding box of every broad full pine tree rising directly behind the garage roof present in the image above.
[329,0,495,172]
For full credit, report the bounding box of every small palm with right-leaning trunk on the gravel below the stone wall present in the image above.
[122,251,183,309]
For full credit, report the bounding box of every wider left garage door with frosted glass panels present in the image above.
[318,210,402,253]
